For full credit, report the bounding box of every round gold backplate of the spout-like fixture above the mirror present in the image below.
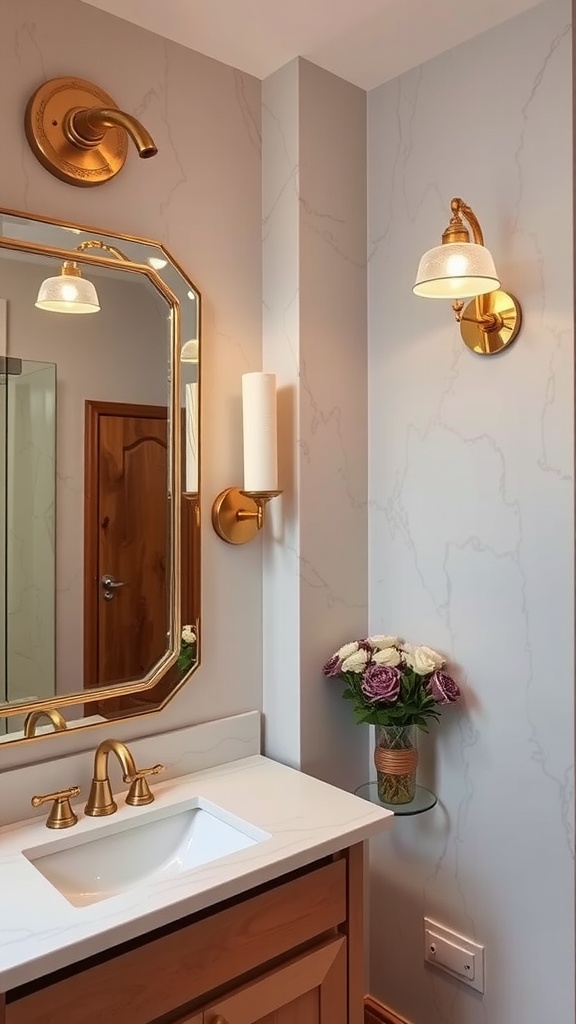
[25,78,128,187]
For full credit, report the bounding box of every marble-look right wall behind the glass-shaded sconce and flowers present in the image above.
[369,0,574,1024]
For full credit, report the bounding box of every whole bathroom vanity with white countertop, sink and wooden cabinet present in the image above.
[0,756,393,1024]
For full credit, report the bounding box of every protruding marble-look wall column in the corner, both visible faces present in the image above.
[263,59,367,787]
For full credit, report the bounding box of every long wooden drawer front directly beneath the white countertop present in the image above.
[6,859,346,1024]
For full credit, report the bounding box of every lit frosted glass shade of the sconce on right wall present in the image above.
[413,242,500,299]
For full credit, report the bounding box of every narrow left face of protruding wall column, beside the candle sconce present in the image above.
[262,60,301,767]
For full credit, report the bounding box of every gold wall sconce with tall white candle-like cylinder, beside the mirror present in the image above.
[212,373,282,544]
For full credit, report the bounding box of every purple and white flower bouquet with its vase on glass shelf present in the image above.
[323,636,460,804]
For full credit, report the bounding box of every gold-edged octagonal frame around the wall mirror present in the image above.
[0,203,201,751]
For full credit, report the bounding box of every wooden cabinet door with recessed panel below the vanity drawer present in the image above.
[196,938,347,1024]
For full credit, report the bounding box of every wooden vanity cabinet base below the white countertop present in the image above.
[0,846,364,1024]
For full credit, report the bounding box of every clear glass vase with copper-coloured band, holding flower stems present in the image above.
[374,725,418,804]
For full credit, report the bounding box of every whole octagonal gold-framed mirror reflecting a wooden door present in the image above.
[0,210,200,743]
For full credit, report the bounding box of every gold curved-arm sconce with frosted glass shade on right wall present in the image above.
[413,198,522,355]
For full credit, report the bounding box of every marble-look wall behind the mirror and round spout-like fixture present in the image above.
[0,0,261,765]
